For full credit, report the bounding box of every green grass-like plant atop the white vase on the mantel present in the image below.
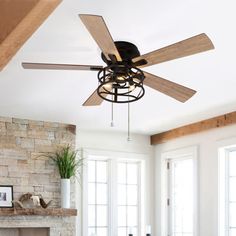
[48,145,83,179]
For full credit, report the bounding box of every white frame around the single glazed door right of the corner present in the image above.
[161,146,199,236]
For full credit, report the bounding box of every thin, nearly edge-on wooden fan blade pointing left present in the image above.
[22,62,103,70]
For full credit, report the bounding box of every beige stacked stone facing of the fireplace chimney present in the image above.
[0,117,75,235]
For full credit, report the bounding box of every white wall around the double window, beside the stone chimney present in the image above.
[76,130,154,236]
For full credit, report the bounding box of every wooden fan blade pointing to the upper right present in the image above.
[132,33,214,67]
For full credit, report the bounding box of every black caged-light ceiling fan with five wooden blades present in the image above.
[22,14,214,106]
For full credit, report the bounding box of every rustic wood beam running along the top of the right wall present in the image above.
[151,111,236,145]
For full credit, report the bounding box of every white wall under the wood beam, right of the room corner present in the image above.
[154,125,236,236]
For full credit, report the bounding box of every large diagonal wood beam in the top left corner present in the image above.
[0,0,62,71]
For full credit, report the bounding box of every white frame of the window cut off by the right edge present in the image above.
[218,142,236,236]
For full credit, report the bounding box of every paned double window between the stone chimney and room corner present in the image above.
[83,156,144,236]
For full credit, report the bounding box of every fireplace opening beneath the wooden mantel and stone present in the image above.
[0,228,49,236]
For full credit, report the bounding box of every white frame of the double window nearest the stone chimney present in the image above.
[80,149,147,236]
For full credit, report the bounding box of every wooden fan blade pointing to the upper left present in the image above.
[79,14,122,61]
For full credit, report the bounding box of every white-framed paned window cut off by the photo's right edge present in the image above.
[219,146,236,236]
